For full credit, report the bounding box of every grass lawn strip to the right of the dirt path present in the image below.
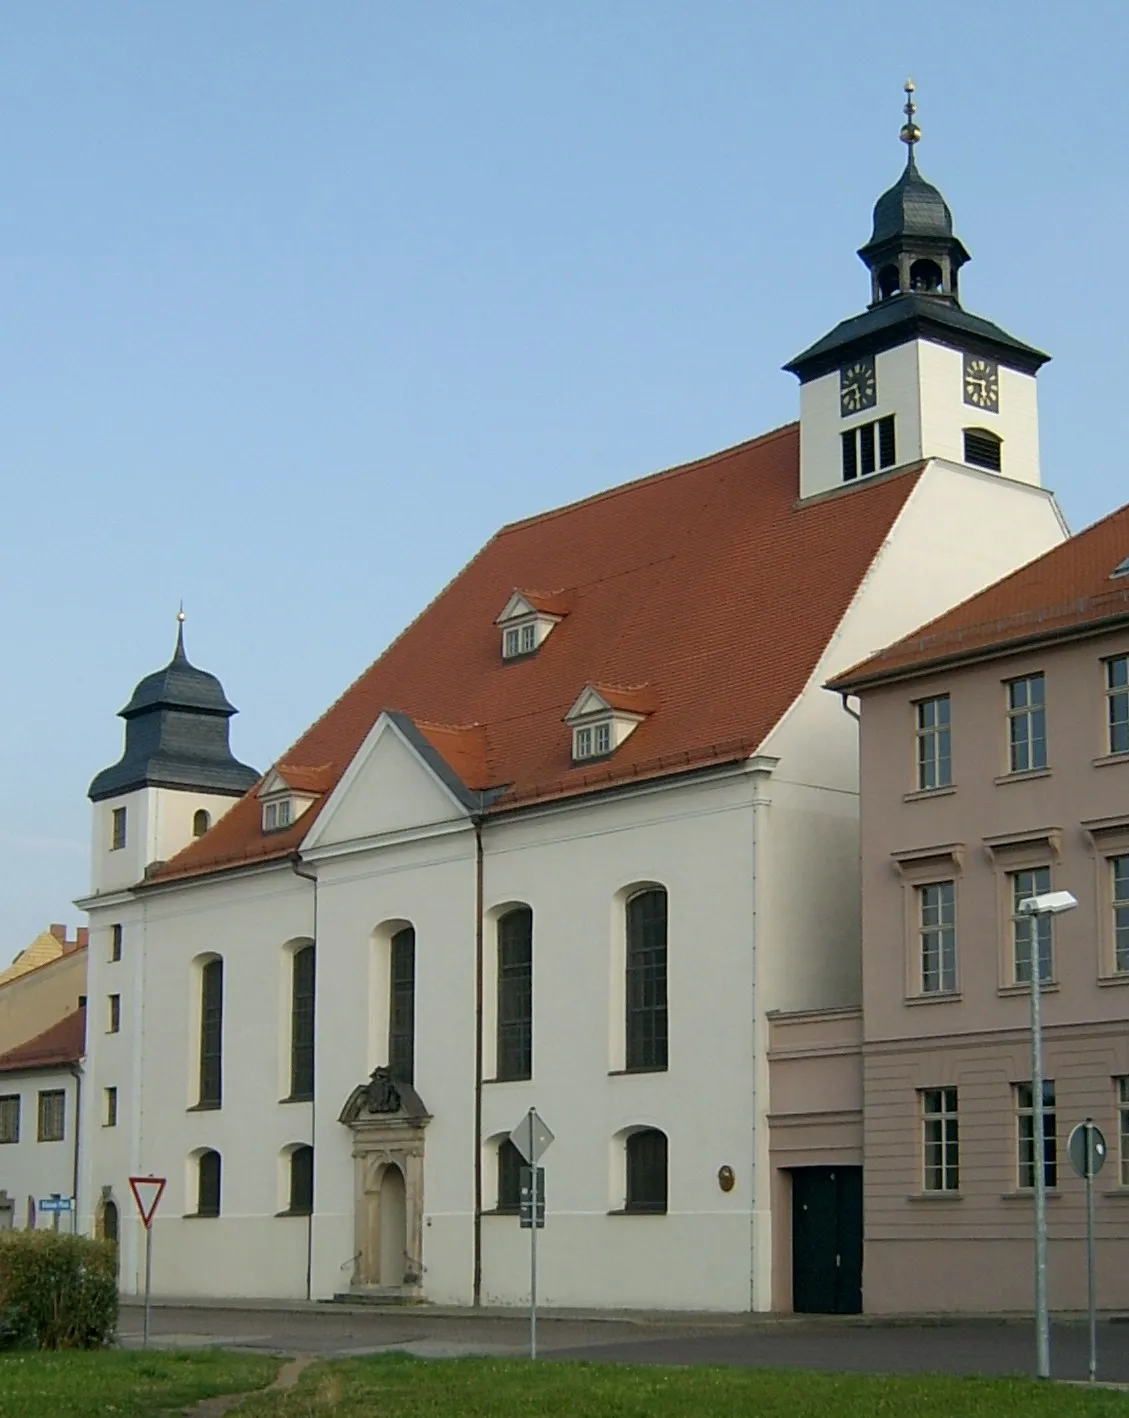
[238,1354,1129,1418]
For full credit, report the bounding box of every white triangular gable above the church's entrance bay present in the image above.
[301,710,481,852]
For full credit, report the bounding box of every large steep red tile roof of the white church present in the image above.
[150,424,918,881]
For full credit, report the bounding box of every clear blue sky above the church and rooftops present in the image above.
[0,0,1129,959]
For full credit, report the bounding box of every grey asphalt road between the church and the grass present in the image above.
[121,1306,1129,1383]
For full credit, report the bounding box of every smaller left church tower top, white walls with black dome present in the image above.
[88,610,258,893]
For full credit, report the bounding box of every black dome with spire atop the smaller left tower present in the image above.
[89,624,258,803]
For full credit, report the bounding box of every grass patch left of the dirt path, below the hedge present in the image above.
[0,1349,281,1418]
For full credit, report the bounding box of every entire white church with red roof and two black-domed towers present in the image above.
[79,102,1065,1310]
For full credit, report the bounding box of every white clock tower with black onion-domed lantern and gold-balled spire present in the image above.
[784,82,1048,498]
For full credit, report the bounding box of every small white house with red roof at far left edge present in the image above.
[0,1007,85,1231]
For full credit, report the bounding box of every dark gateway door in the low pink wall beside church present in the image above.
[791,1167,862,1314]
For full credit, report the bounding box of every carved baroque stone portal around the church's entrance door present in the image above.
[340,1068,431,1299]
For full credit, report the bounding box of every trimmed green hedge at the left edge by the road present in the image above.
[0,1231,118,1349]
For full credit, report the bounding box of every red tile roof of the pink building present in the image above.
[828,505,1129,691]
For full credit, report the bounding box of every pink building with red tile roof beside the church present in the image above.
[822,506,1129,1313]
